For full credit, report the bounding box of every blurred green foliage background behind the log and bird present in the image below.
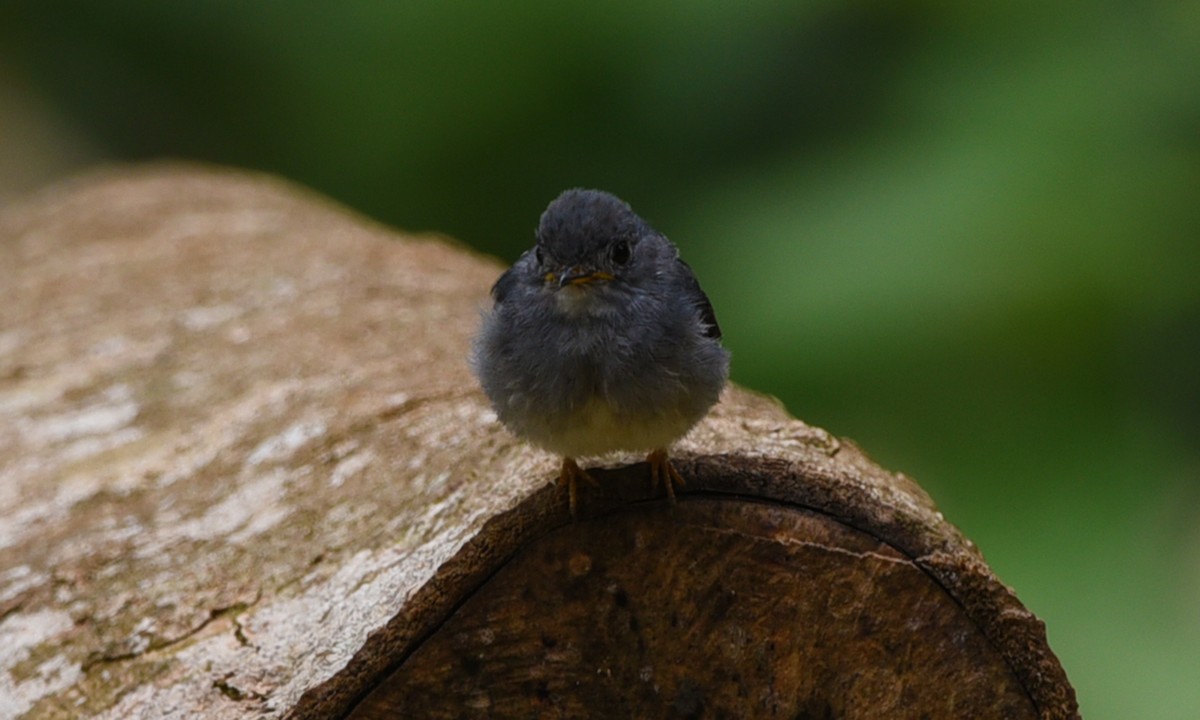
[0,0,1200,720]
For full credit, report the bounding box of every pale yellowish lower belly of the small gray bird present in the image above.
[528,397,698,457]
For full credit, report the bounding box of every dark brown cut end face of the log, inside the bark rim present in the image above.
[352,496,1037,720]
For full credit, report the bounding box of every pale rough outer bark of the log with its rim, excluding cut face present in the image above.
[0,164,1075,719]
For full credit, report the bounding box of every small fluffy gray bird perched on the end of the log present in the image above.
[472,190,730,516]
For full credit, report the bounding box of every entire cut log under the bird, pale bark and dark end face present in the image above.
[0,166,1076,718]
